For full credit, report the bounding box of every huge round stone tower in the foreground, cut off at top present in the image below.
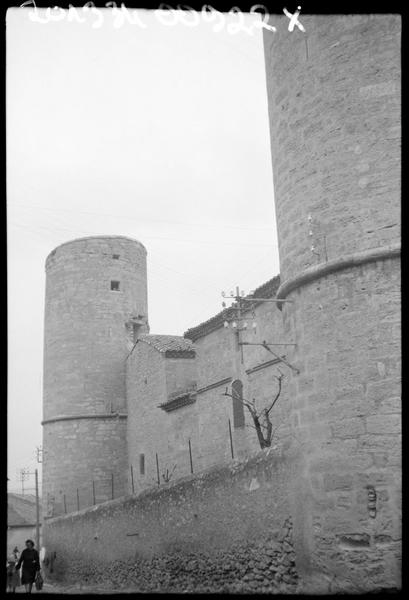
[264,14,401,592]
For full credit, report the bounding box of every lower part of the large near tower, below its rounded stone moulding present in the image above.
[284,260,402,592]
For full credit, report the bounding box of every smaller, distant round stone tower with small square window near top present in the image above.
[43,236,148,517]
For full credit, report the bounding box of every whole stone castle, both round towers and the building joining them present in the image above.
[43,15,401,592]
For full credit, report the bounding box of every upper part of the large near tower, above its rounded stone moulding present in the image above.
[264,15,401,282]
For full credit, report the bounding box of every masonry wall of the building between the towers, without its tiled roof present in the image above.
[127,290,292,491]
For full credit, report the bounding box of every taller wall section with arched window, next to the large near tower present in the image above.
[194,302,293,468]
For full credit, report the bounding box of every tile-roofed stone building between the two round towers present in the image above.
[127,277,291,491]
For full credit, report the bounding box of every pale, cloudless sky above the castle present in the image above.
[6,8,279,491]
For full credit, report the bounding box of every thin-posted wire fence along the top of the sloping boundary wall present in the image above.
[43,419,235,518]
